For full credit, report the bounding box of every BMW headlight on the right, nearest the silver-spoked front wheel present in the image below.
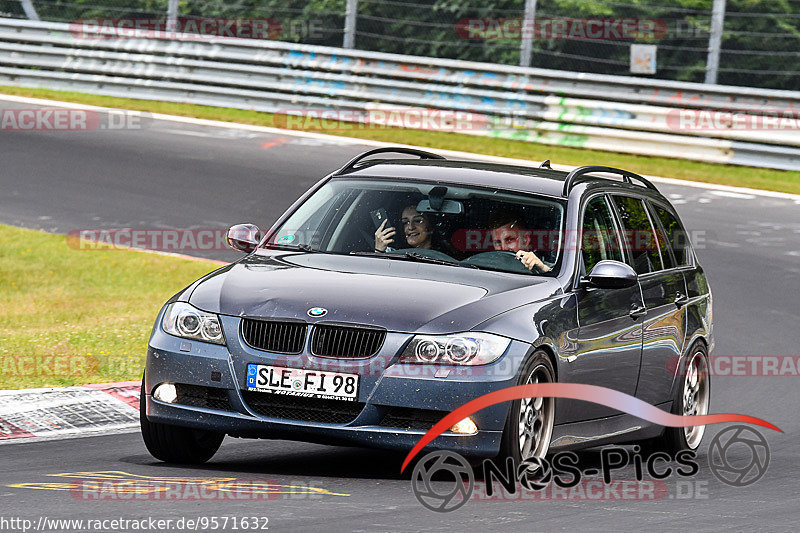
[400,333,511,365]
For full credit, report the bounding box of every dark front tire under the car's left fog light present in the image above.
[139,380,225,464]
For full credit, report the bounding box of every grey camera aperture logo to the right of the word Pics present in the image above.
[708,425,769,487]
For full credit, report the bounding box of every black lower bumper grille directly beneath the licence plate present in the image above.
[242,391,364,424]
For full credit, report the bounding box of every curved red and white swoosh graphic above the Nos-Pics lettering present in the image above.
[400,383,783,472]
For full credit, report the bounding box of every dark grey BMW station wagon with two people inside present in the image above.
[141,148,713,462]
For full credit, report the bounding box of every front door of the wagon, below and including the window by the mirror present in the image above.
[559,195,642,422]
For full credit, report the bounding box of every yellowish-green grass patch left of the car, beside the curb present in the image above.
[0,225,216,389]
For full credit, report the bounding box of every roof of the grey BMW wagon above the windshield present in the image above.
[333,159,663,199]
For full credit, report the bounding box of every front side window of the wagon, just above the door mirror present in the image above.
[581,196,625,273]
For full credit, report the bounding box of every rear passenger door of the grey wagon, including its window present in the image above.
[613,195,687,404]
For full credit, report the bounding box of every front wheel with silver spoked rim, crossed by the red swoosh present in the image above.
[498,350,556,464]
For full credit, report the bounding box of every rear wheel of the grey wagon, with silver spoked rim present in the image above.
[640,342,711,455]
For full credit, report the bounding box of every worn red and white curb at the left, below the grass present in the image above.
[0,381,141,444]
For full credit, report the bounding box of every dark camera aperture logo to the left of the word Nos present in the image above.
[411,451,475,513]
